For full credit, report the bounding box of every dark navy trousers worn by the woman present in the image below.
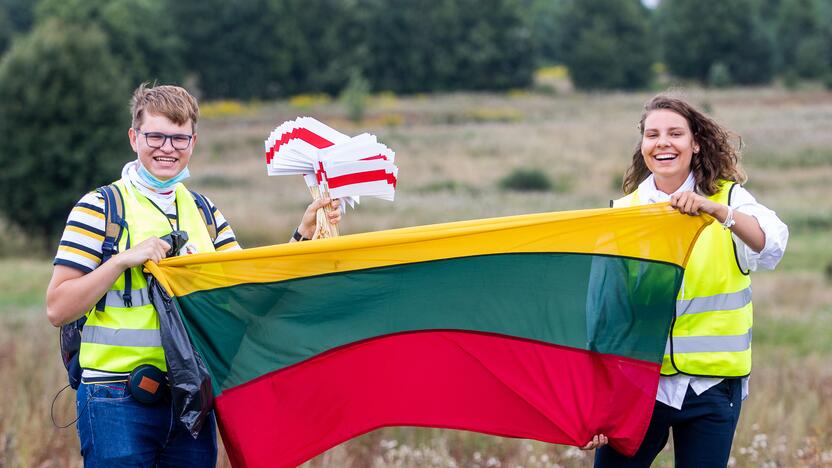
[595,379,742,468]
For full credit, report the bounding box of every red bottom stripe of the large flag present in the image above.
[215,331,659,467]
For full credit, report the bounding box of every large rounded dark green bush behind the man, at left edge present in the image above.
[0,20,130,248]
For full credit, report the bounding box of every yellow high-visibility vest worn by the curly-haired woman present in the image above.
[613,181,753,377]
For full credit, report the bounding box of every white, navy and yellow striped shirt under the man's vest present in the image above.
[52,192,240,273]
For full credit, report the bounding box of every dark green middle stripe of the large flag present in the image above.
[177,253,683,393]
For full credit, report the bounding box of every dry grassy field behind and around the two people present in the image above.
[0,88,832,467]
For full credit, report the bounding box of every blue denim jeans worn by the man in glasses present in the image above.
[76,383,217,468]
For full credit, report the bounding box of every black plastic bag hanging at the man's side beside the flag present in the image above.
[148,276,214,438]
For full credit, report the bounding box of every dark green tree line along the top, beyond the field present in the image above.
[0,0,832,99]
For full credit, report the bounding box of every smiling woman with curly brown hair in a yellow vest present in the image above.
[590,95,788,467]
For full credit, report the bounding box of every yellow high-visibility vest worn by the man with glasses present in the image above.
[79,181,214,372]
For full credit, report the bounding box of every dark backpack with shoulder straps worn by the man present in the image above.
[60,184,217,390]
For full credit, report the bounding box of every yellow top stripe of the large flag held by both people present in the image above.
[148,203,712,296]
